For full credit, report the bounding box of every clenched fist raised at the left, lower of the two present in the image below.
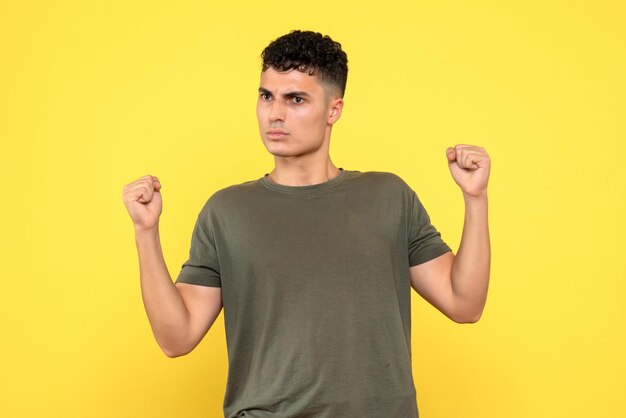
[122,175,163,230]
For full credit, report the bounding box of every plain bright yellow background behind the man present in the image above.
[0,0,626,418]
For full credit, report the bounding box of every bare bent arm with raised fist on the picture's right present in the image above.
[410,144,491,323]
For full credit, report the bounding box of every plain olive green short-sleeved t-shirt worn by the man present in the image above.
[176,169,450,418]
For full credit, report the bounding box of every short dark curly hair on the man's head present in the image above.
[261,30,348,97]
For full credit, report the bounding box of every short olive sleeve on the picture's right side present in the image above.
[408,191,452,267]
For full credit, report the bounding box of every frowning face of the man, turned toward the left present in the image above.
[256,67,343,157]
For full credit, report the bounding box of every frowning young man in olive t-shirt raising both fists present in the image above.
[123,31,490,418]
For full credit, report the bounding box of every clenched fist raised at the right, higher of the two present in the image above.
[446,144,491,197]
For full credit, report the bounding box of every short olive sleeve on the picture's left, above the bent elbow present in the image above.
[176,213,222,287]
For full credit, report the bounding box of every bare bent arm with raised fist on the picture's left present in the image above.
[123,176,222,357]
